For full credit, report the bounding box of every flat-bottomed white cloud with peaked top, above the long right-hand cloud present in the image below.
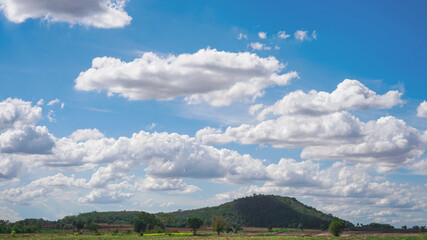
[258,79,403,120]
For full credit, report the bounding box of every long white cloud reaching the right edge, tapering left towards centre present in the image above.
[196,116,427,172]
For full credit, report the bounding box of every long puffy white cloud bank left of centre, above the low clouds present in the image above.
[39,131,265,185]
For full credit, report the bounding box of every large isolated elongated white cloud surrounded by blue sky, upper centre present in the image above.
[75,48,298,106]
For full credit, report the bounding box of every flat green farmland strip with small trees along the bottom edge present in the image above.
[0,225,427,240]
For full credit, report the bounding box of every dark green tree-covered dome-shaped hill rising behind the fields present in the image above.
[164,194,351,228]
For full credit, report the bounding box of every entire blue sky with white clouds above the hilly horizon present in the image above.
[0,0,427,226]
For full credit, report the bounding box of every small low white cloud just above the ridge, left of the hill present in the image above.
[79,189,133,204]
